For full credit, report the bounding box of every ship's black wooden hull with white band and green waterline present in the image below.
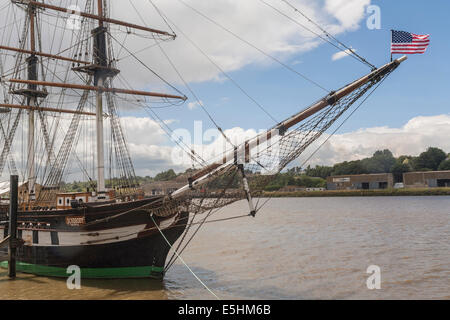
[0,198,188,278]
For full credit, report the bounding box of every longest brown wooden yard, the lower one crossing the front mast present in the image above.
[5,79,187,100]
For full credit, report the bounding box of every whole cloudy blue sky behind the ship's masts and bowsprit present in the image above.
[0,0,450,180]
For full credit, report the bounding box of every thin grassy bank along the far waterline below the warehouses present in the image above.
[264,188,450,198]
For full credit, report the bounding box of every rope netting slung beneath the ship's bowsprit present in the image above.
[148,72,390,216]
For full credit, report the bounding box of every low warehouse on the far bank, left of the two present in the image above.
[327,173,394,190]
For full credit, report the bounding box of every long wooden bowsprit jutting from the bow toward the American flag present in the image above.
[170,56,407,198]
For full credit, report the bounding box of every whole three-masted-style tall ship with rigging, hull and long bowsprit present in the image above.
[0,0,406,278]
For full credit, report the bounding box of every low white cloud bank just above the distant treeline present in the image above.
[2,114,450,181]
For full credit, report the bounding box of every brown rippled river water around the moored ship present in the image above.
[0,197,450,299]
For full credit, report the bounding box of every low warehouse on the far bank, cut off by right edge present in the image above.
[403,170,450,188]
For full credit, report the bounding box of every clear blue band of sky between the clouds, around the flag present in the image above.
[158,0,450,133]
